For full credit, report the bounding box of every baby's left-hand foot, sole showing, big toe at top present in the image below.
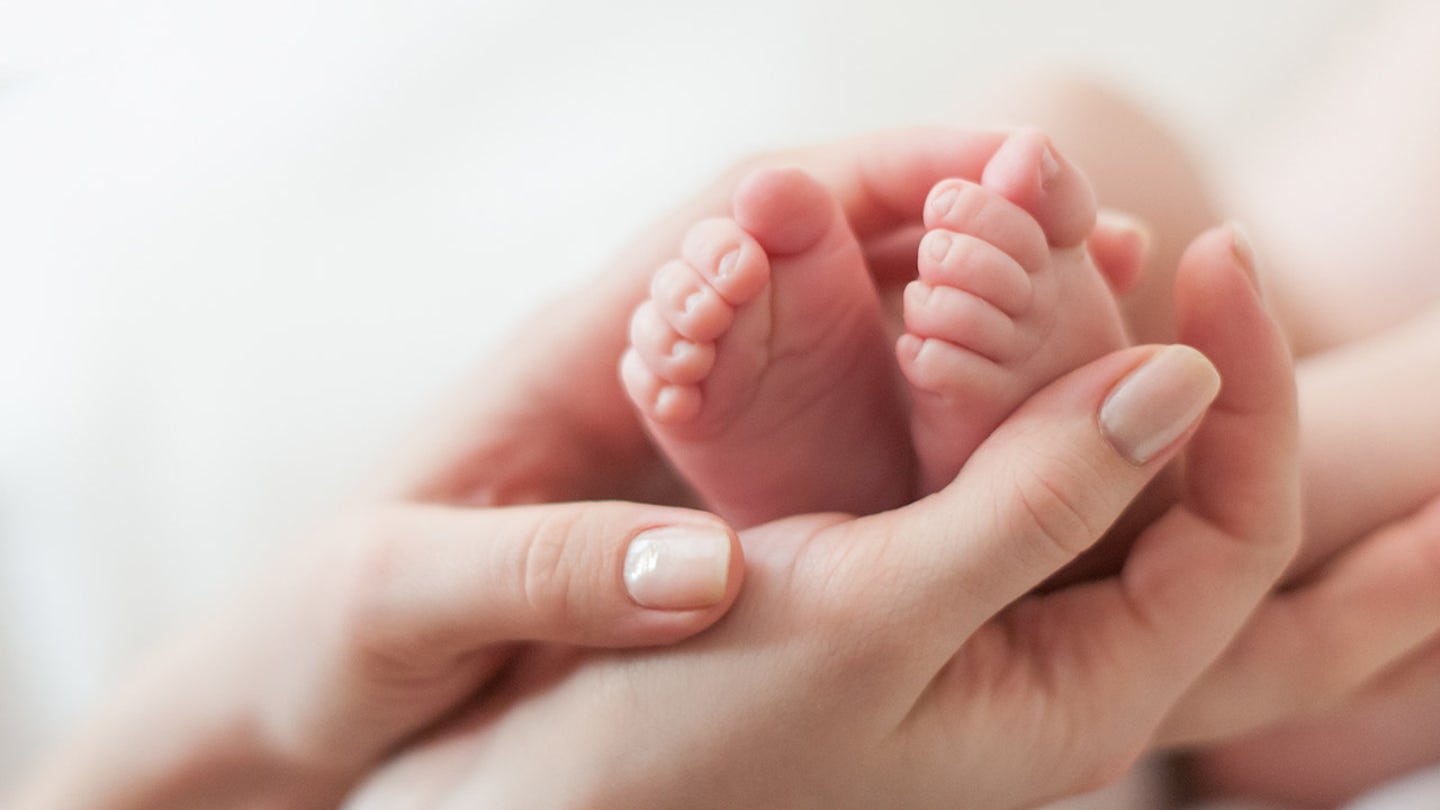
[621,170,914,526]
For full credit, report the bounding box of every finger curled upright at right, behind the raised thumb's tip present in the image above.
[1031,223,1299,735]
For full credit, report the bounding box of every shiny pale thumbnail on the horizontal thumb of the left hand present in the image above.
[625,526,730,610]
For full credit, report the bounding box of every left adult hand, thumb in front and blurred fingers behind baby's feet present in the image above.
[8,130,1044,807]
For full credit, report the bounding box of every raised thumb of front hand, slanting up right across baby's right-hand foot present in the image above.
[848,337,1220,639]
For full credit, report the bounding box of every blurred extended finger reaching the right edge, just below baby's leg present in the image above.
[1161,484,1440,744]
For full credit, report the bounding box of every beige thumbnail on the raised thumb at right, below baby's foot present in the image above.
[1100,346,1220,464]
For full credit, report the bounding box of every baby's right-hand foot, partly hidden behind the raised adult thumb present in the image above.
[896,133,1128,494]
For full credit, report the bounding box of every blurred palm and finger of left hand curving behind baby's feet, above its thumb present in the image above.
[377,128,1065,504]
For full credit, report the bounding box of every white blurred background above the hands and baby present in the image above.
[0,0,1416,788]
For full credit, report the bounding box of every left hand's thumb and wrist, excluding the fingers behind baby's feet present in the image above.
[7,503,742,809]
